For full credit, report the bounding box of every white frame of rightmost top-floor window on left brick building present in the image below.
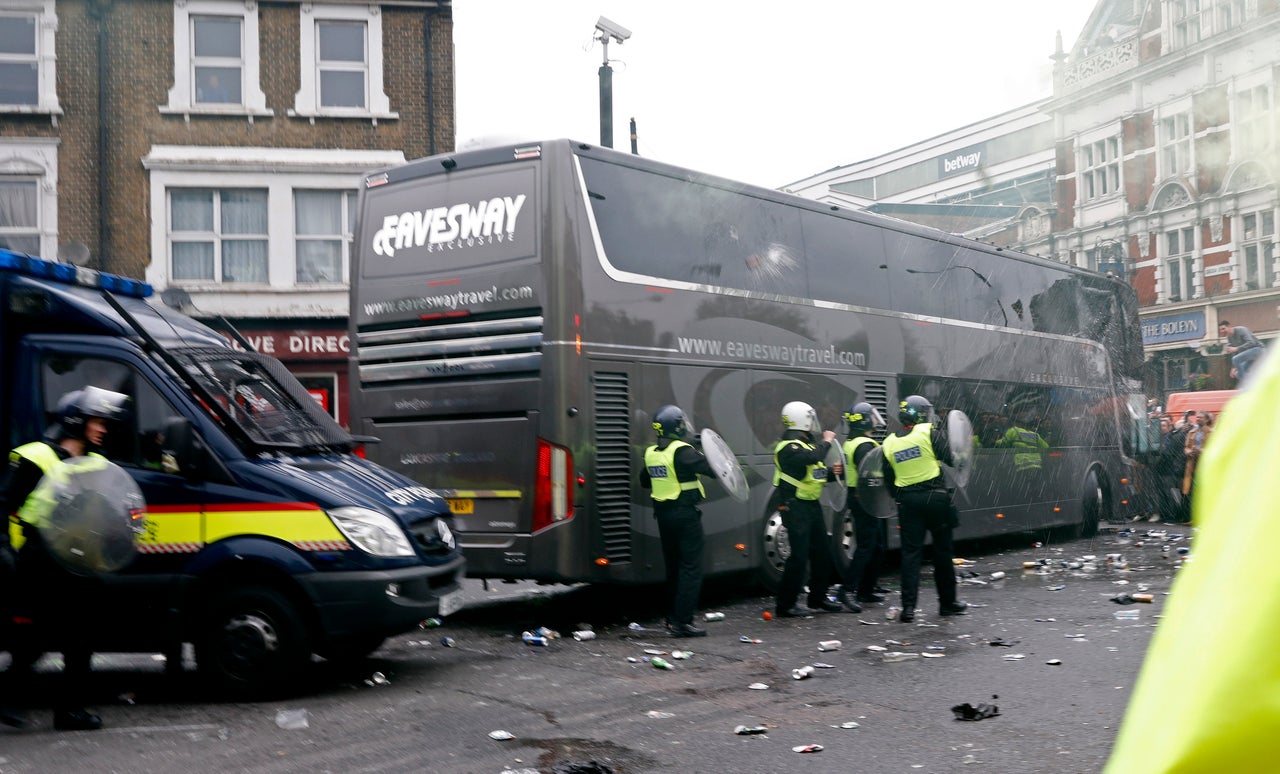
[289,3,399,123]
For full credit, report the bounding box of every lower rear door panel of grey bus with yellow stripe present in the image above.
[367,416,538,537]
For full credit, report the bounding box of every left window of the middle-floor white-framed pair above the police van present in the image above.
[169,188,268,283]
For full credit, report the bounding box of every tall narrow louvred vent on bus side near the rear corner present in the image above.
[593,371,631,562]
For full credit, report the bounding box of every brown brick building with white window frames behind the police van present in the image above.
[0,0,454,423]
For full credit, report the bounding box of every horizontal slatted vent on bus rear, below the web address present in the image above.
[356,310,543,386]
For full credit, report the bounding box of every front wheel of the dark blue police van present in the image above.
[196,586,311,699]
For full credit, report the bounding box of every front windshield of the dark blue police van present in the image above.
[175,348,353,450]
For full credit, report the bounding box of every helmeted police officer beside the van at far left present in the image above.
[0,386,128,731]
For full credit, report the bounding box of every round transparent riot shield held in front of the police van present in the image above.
[31,457,146,574]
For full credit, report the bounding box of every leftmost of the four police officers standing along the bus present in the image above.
[640,406,716,637]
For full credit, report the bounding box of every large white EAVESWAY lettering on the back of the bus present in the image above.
[372,193,525,256]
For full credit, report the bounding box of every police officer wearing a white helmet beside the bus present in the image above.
[768,400,840,618]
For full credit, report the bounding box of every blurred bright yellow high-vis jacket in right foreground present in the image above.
[1106,347,1280,774]
